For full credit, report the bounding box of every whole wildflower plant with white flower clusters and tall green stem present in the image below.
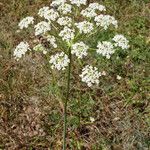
[14,0,129,150]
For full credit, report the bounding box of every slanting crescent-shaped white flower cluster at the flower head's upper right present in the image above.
[81,3,106,18]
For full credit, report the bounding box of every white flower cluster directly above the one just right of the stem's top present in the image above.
[75,21,94,34]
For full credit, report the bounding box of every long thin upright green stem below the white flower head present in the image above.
[63,48,71,150]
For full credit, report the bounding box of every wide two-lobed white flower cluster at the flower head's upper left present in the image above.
[38,7,59,21]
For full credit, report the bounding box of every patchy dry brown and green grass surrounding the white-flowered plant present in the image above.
[0,0,150,150]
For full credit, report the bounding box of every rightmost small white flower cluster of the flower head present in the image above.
[113,34,130,49]
